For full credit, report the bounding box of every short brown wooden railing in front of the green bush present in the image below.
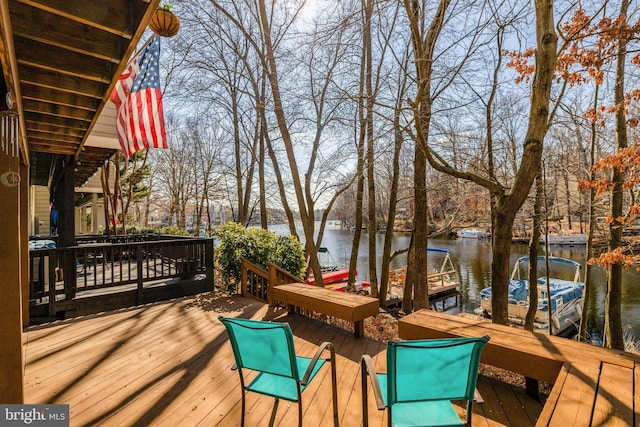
[240,258,302,304]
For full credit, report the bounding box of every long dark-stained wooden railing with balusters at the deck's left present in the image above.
[29,236,214,316]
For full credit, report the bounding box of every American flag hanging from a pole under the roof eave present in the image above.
[111,36,168,159]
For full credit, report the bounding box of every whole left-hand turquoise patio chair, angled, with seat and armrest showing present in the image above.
[219,316,338,426]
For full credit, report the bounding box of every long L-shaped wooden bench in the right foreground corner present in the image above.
[398,310,640,427]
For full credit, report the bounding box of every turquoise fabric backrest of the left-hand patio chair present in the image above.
[220,316,300,381]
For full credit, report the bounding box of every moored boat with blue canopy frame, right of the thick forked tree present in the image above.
[476,255,584,335]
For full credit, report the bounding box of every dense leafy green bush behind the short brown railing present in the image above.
[213,222,305,285]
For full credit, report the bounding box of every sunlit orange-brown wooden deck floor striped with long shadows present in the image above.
[25,294,542,427]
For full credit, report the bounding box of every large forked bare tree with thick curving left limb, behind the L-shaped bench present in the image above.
[405,0,557,324]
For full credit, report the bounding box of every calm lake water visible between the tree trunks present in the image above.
[270,226,640,341]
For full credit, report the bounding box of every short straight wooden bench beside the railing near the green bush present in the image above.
[271,283,380,337]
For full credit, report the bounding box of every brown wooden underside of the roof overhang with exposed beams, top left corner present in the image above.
[0,0,160,184]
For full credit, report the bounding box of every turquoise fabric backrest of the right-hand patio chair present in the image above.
[387,336,489,405]
